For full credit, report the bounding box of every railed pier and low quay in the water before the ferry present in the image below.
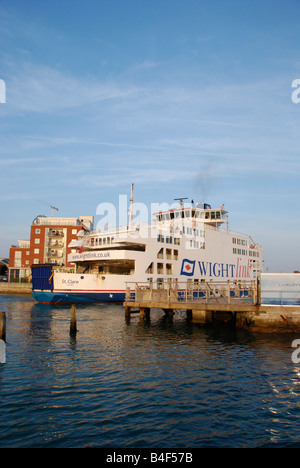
[124,279,300,333]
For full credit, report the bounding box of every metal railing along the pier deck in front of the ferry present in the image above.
[125,280,259,304]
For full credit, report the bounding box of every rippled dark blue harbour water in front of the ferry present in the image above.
[0,295,300,448]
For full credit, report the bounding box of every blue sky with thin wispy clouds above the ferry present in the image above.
[0,0,300,272]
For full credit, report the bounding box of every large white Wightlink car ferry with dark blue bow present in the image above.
[32,188,263,304]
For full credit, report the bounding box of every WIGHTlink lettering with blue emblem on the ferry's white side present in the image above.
[180,258,251,279]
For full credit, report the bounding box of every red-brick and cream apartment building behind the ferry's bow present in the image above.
[9,215,94,281]
